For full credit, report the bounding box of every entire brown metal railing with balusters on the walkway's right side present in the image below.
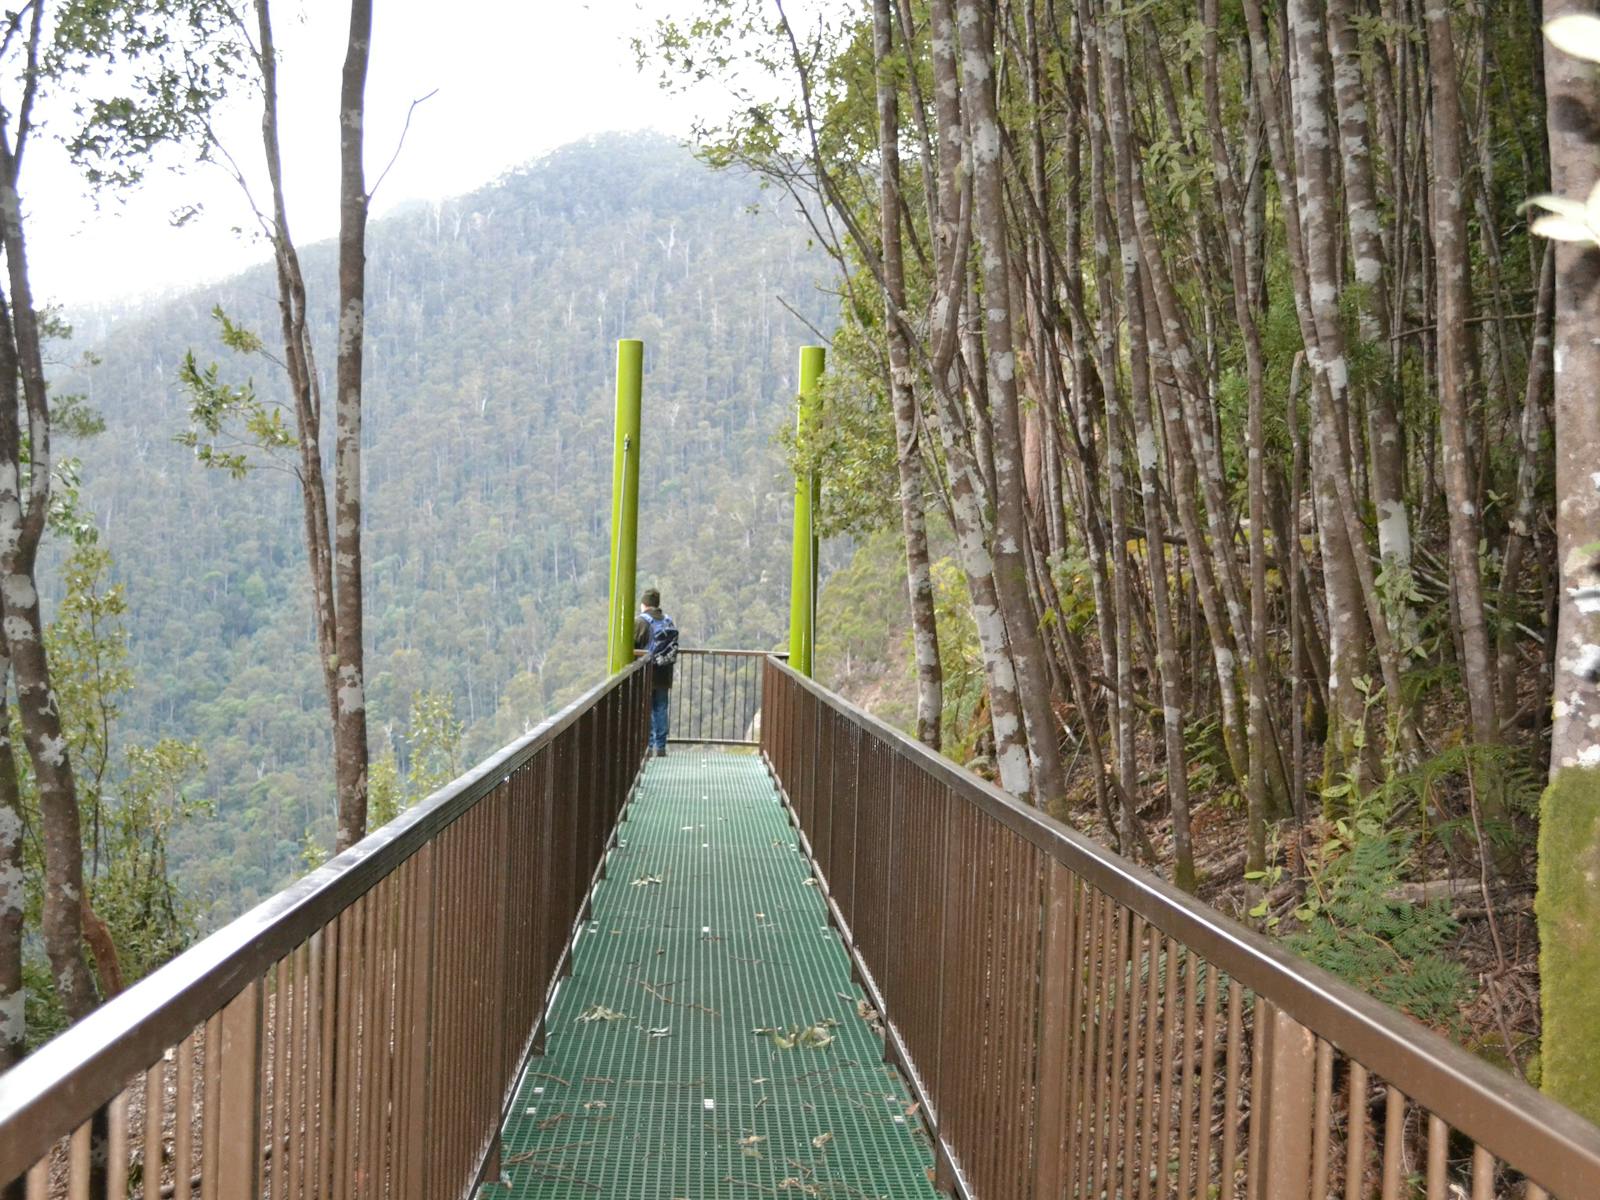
[762,661,1600,1200]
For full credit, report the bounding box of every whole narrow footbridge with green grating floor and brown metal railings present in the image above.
[0,651,1600,1200]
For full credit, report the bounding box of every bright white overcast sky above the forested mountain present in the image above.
[22,0,715,307]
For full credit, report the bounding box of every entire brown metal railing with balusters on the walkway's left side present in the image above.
[0,664,650,1200]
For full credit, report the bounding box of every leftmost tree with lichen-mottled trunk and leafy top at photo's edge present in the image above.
[0,0,237,1067]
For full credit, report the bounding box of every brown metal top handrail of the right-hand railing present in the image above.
[758,661,1600,1195]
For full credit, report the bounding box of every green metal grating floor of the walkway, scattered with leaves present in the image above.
[478,749,936,1200]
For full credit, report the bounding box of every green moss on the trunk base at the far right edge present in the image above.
[1534,766,1600,1120]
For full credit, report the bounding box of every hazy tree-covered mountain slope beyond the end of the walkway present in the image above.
[58,136,834,915]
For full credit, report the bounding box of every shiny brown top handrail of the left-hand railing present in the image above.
[0,661,645,1181]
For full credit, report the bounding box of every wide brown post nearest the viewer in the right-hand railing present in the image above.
[1251,997,1317,1200]
